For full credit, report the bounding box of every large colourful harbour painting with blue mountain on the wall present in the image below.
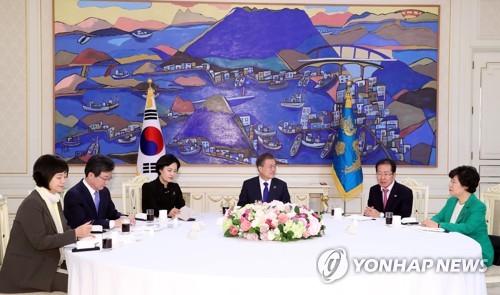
[54,0,439,166]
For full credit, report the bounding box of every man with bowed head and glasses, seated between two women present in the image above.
[64,155,135,228]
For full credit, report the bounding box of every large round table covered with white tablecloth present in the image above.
[66,213,486,295]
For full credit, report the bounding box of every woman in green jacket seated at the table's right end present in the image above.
[422,166,494,266]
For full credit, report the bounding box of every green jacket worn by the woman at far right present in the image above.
[431,194,494,266]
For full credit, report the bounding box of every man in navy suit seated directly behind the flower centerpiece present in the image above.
[238,153,290,206]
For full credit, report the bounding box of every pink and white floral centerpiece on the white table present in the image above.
[223,201,325,242]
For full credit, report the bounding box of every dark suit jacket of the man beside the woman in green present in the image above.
[368,181,413,218]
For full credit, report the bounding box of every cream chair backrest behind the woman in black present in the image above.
[122,175,151,215]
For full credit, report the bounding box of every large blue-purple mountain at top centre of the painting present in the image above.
[181,7,328,60]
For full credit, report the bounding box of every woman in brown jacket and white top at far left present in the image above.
[0,155,92,293]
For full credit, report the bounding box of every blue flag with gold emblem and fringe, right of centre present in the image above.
[333,81,363,201]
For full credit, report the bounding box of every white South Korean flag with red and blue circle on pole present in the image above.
[137,79,165,179]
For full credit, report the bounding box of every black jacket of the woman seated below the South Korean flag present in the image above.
[142,177,186,217]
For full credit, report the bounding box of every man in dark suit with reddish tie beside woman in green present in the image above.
[365,159,413,218]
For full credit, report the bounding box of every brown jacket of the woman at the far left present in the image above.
[0,190,76,293]
